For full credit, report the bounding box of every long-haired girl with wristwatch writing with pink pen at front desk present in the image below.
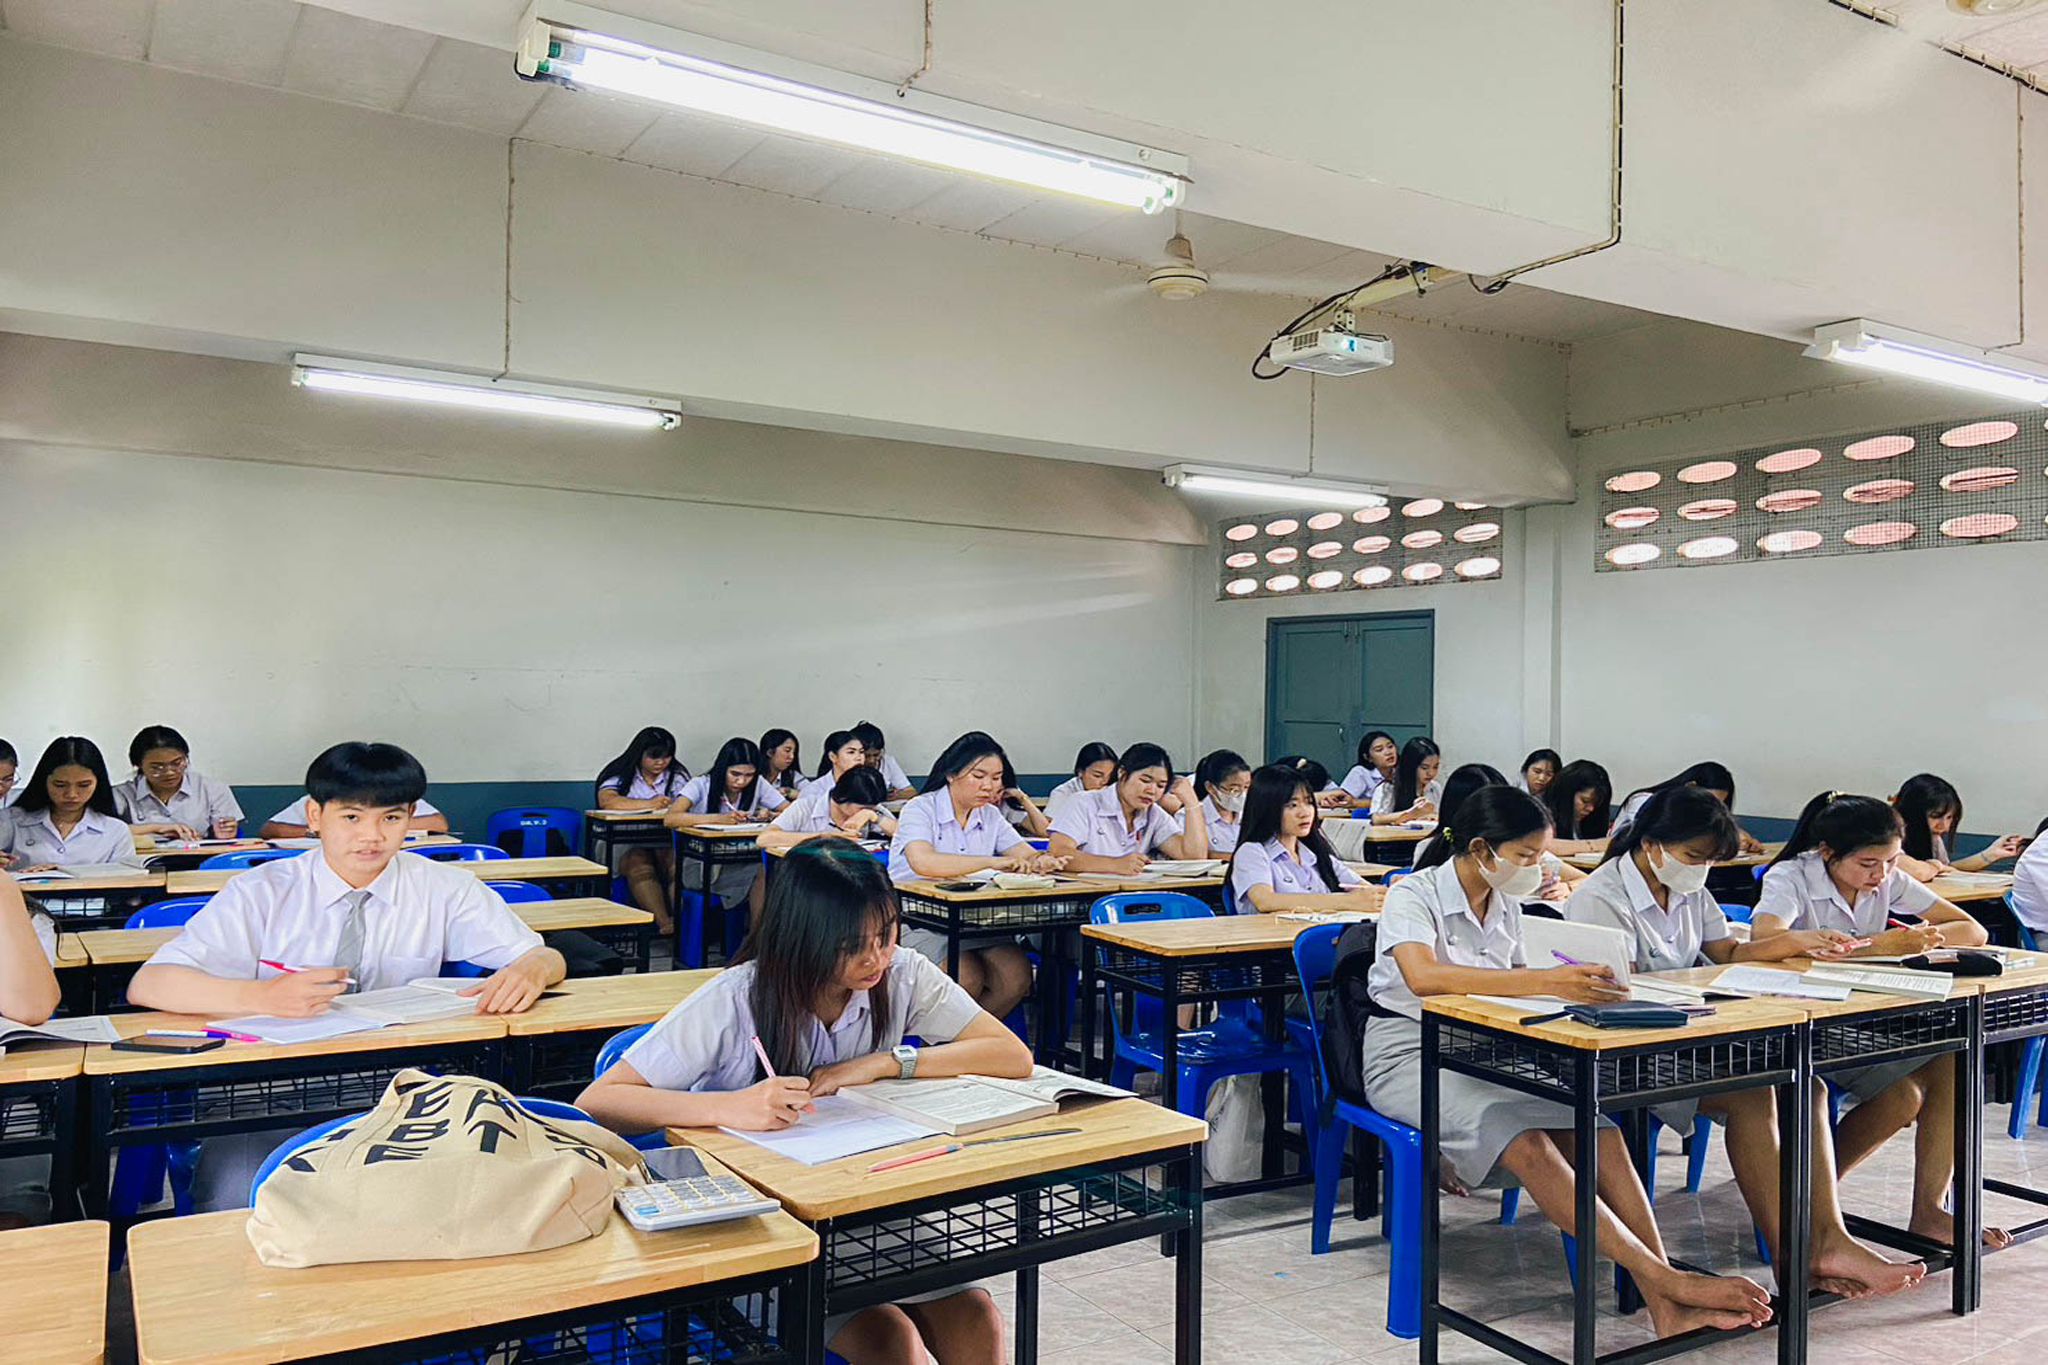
[575,843,1032,1365]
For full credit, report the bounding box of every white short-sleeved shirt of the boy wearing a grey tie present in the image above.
[150,849,541,990]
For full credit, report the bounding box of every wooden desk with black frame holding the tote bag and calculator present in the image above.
[123,1186,817,1365]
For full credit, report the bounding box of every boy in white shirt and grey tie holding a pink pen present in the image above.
[129,743,567,1207]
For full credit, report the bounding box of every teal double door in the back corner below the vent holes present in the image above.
[1266,612,1436,778]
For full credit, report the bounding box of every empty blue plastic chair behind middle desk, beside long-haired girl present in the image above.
[1087,892,1315,1142]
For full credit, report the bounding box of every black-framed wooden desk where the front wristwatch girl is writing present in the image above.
[668,1099,1208,1365]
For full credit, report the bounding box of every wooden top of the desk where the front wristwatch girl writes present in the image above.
[668,1099,1208,1220]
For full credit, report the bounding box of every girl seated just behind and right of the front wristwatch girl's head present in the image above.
[889,731,1067,1019]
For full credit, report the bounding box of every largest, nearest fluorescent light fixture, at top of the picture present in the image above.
[514,0,1188,213]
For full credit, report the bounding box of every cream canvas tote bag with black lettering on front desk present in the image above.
[248,1070,641,1267]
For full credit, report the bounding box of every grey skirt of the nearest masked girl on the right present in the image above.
[1364,1015,1614,1189]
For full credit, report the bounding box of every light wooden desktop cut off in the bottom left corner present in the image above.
[0,1222,109,1365]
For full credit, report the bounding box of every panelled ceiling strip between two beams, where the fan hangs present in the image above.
[0,0,1661,344]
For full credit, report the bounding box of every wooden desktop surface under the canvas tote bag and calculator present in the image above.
[123,1186,817,1365]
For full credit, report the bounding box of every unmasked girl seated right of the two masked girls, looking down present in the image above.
[1749,792,2013,1246]
